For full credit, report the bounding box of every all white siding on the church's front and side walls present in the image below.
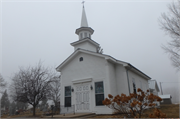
[58,53,148,114]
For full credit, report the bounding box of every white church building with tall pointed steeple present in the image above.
[56,7,151,114]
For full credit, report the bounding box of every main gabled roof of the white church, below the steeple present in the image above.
[56,48,151,80]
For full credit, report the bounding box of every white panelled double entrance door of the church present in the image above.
[75,84,90,112]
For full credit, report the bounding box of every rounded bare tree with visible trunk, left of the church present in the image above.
[11,63,54,116]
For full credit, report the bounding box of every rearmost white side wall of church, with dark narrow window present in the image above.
[128,70,149,93]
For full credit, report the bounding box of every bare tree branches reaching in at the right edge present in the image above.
[159,0,180,70]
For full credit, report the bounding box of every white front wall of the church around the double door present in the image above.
[61,53,112,114]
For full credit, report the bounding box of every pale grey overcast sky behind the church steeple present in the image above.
[0,0,179,102]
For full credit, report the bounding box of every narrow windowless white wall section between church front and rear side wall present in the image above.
[116,64,129,95]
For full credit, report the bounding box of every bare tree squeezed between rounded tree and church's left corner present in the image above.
[49,76,61,111]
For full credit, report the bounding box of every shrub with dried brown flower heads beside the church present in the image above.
[103,88,162,118]
